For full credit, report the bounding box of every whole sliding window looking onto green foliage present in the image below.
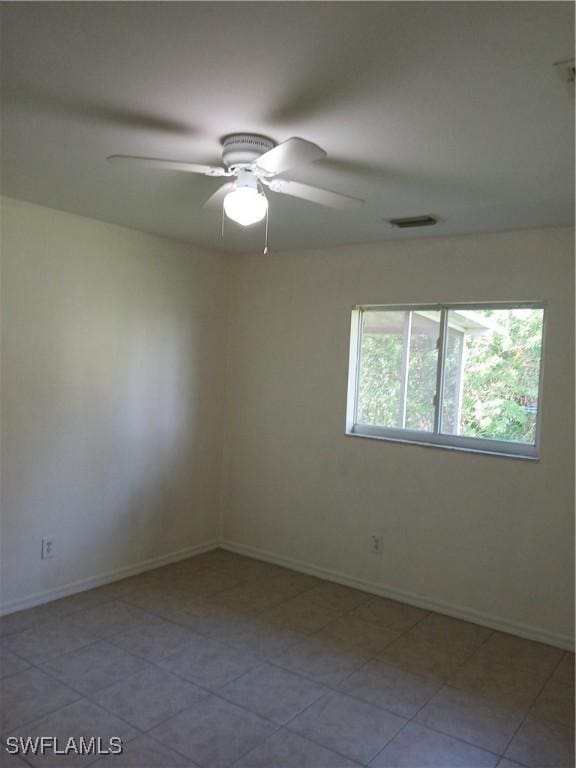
[346,304,544,457]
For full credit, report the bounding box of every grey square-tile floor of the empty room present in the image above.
[0,550,574,768]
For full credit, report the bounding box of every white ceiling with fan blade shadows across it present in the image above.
[1,2,574,251]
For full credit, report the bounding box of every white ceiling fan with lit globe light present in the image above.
[108,133,364,227]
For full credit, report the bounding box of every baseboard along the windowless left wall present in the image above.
[0,539,219,616]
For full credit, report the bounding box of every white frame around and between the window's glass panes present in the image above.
[346,301,547,460]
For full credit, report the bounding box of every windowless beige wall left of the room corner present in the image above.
[0,200,227,605]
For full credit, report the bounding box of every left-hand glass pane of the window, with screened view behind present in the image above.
[357,310,440,431]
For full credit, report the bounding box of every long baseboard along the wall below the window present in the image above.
[219,540,574,651]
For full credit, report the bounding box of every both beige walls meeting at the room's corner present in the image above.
[0,195,574,644]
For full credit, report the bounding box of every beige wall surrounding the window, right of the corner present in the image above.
[224,229,574,643]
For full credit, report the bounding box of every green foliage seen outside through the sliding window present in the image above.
[358,309,543,443]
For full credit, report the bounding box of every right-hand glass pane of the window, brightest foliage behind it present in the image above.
[441,309,544,444]
